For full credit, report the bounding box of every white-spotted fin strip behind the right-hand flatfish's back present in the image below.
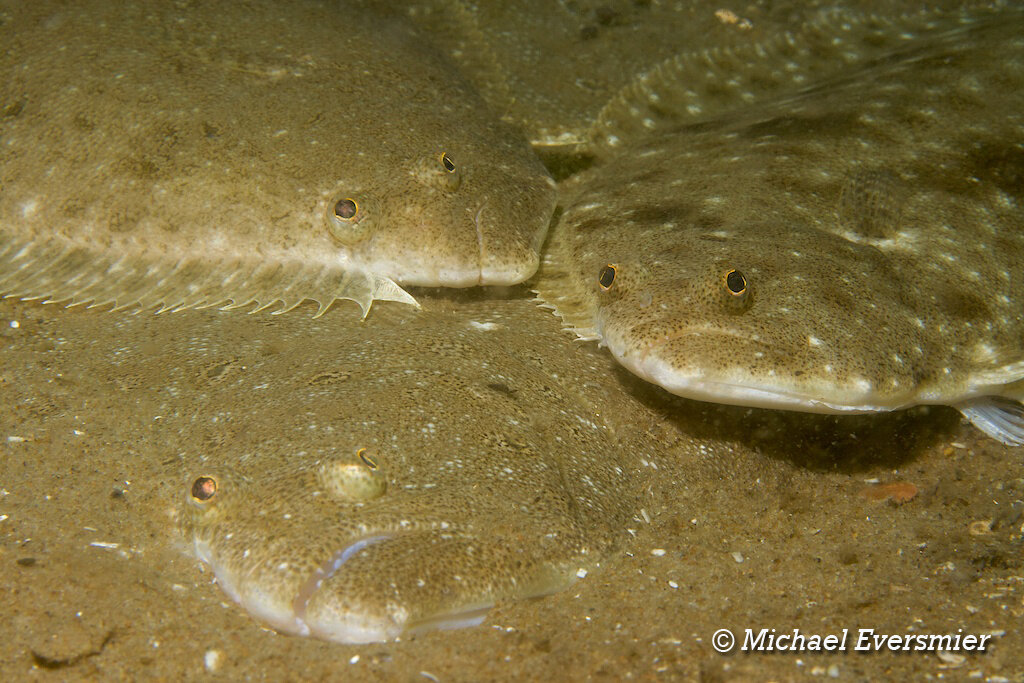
[590,9,983,155]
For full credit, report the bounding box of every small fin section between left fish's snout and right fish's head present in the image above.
[532,204,600,341]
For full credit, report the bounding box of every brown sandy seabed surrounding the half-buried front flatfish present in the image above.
[0,298,1024,681]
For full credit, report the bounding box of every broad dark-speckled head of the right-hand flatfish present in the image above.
[593,225,928,413]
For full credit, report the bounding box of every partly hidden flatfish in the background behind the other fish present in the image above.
[410,0,983,156]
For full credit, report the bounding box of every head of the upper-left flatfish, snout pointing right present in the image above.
[324,124,555,287]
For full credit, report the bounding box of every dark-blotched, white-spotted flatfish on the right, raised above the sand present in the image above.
[537,10,1024,444]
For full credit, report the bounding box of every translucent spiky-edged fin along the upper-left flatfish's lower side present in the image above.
[0,233,419,318]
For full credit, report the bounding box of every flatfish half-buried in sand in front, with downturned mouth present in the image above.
[171,299,656,642]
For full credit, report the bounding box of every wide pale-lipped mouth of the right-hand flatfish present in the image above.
[601,328,903,415]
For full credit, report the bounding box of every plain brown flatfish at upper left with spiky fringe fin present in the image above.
[0,0,554,313]
